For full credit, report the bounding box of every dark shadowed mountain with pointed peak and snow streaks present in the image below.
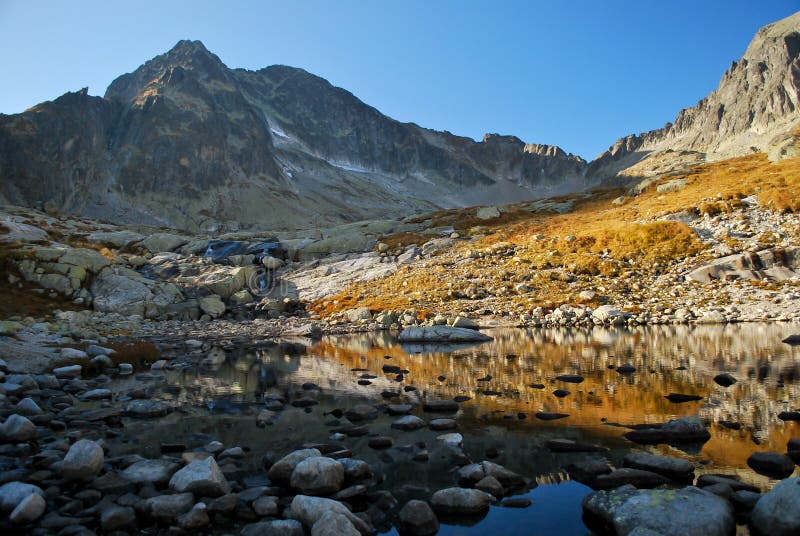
[0,37,589,230]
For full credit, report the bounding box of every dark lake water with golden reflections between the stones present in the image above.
[106,324,800,534]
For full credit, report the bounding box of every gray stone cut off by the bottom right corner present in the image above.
[750,477,800,536]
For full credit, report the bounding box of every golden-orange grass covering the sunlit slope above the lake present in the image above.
[311,154,800,316]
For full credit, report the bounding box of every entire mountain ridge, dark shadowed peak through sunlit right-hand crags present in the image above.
[0,13,800,231]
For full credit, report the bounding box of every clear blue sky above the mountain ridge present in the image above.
[0,0,800,159]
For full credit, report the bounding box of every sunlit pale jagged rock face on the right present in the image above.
[587,13,800,176]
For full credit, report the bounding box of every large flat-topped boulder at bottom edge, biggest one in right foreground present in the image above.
[583,486,736,536]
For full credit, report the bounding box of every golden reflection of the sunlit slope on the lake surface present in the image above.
[153,324,800,474]
